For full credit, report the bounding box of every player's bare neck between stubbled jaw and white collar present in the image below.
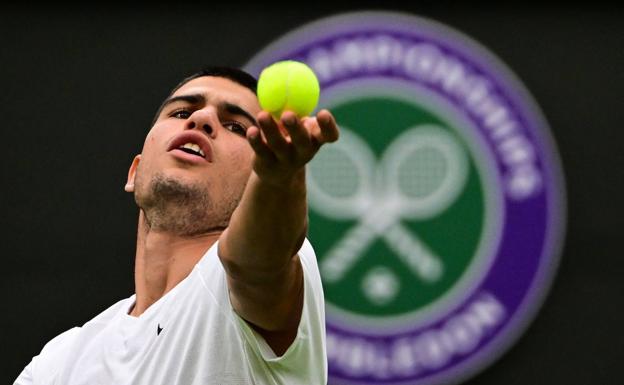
[130,210,222,317]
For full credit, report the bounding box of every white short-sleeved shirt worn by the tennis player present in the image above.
[14,239,327,385]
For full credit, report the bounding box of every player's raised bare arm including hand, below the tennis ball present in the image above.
[219,110,338,354]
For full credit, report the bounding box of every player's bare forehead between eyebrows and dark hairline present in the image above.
[171,76,260,114]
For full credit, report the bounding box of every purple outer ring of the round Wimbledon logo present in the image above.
[245,11,565,384]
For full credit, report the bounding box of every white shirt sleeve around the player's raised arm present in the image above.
[232,239,327,385]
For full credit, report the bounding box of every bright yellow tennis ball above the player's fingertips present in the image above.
[258,60,320,119]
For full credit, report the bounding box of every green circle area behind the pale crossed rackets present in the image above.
[309,96,485,317]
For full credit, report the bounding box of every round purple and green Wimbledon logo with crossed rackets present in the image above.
[246,12,564,384]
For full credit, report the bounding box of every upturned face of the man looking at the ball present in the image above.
[126,76,261,233]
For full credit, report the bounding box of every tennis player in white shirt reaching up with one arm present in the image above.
[14,67,338,385]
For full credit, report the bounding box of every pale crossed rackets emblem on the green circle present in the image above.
[307,124,468,283]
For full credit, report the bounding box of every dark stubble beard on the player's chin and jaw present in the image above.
[135,174,242,237]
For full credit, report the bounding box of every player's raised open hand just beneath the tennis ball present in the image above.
[247,110,339,185]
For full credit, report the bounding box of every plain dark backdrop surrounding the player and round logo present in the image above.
[0,2,624,385]
